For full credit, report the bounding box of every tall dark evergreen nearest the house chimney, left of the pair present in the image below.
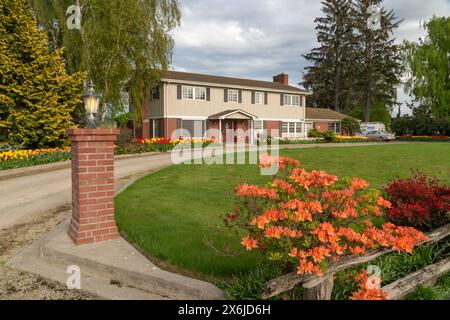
[302,0,354,112]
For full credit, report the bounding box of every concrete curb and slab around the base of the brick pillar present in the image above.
[8,221,224,300]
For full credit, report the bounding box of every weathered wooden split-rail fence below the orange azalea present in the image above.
[262,224,450,300]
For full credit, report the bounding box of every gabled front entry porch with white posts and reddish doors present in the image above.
[209,109,257,144]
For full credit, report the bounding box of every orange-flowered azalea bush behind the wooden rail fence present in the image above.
[226,156,427,275]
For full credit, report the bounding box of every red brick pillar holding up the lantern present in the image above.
[67,129,119,245]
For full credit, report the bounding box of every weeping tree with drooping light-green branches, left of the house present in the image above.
[30,0,181,120]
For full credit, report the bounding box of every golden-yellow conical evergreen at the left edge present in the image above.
[0,0,83,147]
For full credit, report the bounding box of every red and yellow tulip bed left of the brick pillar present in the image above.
[0,147,70,170]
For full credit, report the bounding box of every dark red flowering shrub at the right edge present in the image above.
[386,173,450,231]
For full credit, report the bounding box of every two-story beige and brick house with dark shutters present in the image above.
[135,71,312,143]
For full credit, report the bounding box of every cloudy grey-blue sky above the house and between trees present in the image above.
[173,0,450,111]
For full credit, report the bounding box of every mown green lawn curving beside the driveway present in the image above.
[116,143,450,277]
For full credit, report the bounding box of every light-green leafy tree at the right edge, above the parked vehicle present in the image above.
[404,17,450,119]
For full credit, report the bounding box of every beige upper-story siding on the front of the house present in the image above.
[159,83,306,121]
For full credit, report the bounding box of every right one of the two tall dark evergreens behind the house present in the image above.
[354,0,401,122]
